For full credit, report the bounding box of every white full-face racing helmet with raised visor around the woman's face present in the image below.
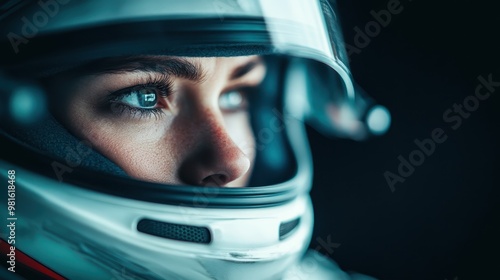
[0,0,390,279]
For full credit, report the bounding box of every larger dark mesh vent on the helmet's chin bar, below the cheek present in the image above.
[137,219,212,244]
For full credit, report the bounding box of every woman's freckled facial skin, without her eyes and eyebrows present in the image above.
[54,56,265,187]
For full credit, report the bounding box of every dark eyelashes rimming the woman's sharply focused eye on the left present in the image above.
[107,75,172,119]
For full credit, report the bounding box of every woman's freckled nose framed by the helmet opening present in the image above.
[179,113,250,186]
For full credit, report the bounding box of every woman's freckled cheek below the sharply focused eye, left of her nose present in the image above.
[68,106,180,183]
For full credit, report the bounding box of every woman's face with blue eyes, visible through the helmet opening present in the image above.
[53,56,266,186]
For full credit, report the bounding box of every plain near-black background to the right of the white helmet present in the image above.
[309,0,500,280]
